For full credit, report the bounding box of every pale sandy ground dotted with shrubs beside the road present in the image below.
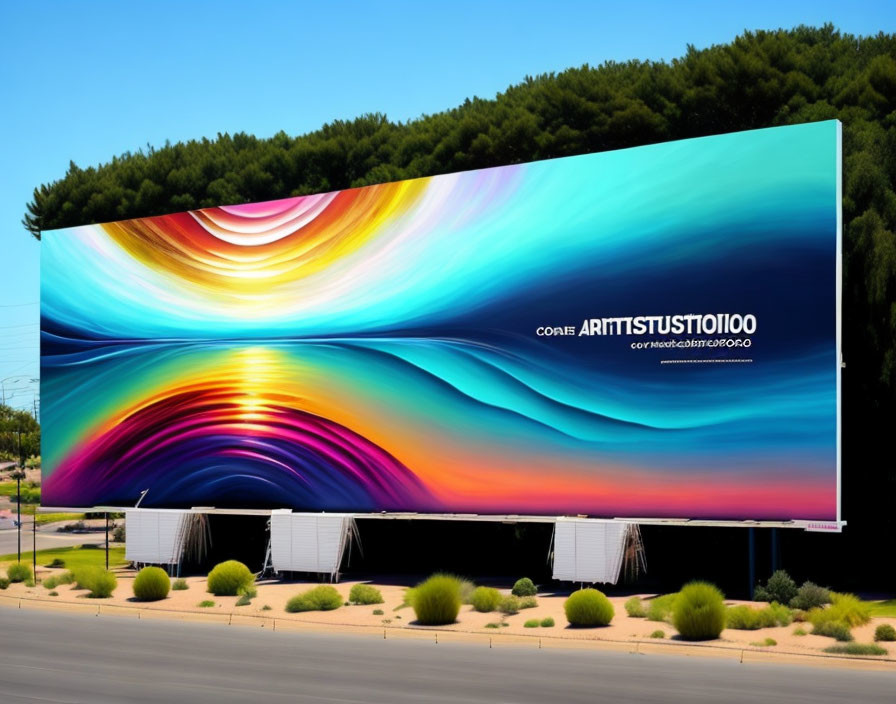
[0,567,896,671]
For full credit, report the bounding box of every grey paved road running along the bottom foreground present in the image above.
[0,607,896,704]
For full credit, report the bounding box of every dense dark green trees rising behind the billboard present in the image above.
[17,25,896,572]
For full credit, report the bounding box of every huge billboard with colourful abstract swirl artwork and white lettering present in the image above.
[41,121,840,521]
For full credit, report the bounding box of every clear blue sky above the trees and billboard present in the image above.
[0,0,896,418]
